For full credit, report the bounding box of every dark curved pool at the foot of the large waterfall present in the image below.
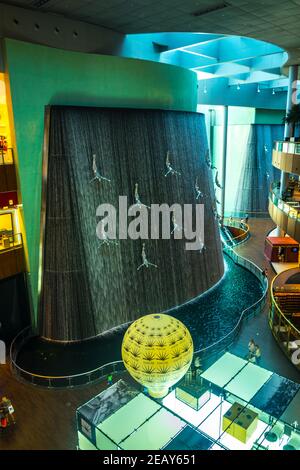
[17,256,262,376]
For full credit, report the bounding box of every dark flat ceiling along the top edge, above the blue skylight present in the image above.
[1,0,300,55]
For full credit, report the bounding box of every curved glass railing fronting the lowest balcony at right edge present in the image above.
[269,274,300,370]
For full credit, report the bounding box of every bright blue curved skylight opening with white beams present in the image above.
[121,33,288,92]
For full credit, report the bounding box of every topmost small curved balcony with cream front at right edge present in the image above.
[272,141,300,175]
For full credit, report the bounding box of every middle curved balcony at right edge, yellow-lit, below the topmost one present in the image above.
[269,183,300,242]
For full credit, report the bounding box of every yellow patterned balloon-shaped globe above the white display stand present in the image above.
[122,313,194,398]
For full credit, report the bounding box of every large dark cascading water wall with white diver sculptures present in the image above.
[39,107,224,341]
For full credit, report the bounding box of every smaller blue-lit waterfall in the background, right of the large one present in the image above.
[234,124,283,217]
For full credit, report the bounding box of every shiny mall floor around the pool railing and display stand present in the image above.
[0,219,300,450]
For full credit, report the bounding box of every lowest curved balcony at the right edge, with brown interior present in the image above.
[269,268,300,370]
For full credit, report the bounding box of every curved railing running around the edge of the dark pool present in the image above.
[10,241,268,388]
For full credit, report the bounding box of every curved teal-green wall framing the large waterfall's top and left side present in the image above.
[3,39,197,318]
